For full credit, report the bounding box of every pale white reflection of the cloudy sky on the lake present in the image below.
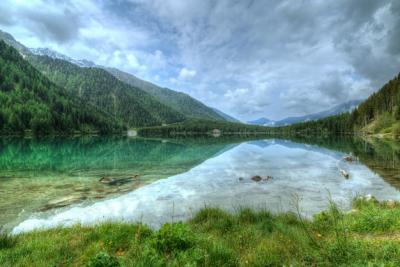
[14,139,400,232]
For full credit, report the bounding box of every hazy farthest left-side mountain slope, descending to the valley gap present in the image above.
[105,68,226,120]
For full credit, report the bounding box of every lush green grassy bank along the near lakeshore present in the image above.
[0,199,400,266]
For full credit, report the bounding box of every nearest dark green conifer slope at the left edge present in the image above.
[0,41,122,134]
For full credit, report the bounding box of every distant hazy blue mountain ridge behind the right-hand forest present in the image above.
[248,100,362,126]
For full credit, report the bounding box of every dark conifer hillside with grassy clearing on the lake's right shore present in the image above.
[275,75,400,137]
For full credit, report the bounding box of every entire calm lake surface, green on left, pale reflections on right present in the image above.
[0,137,400,233]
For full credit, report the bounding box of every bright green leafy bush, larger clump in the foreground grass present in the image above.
[155,223,196,253]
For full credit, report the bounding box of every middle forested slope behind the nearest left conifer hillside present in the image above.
[28,55,184,127]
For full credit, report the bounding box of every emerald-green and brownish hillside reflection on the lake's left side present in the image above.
[0,137,239,227]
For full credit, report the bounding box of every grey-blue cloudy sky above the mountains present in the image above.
[0,0,400,120]
